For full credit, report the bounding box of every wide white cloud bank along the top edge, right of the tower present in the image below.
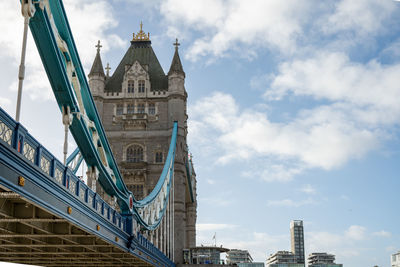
[160,0,396,61]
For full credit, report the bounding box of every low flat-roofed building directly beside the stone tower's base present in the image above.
[183,246,229,264]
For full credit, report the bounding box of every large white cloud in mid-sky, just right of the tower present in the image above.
[189,92,381,181]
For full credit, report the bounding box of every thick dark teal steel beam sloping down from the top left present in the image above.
[29,1,132,214]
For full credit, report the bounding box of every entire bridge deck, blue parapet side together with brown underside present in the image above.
[0,108,175,267]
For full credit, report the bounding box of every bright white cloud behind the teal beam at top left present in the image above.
[0,0,122,101]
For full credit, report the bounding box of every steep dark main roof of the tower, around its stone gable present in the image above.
[105,41,168,92]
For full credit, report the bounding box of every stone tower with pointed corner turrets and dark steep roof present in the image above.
[88,29,197,263]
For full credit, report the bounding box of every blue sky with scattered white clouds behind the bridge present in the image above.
[0,0,400,267]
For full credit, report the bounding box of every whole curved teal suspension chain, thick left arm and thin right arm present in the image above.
[23,0,177,230]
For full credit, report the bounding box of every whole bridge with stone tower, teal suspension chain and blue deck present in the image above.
[0,0,197,266]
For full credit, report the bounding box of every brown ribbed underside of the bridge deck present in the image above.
[0,187,151,267]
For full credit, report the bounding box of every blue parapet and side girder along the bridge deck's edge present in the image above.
[0,105,175,266]
